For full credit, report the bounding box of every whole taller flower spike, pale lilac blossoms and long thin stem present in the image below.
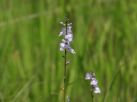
[59,18,75,102]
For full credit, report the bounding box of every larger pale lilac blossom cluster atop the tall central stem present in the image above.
[59,22,75,54]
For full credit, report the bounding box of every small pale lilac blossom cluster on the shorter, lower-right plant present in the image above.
[85,73,101,93]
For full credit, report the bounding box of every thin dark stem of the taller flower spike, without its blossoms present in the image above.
[64,19,68,102]
